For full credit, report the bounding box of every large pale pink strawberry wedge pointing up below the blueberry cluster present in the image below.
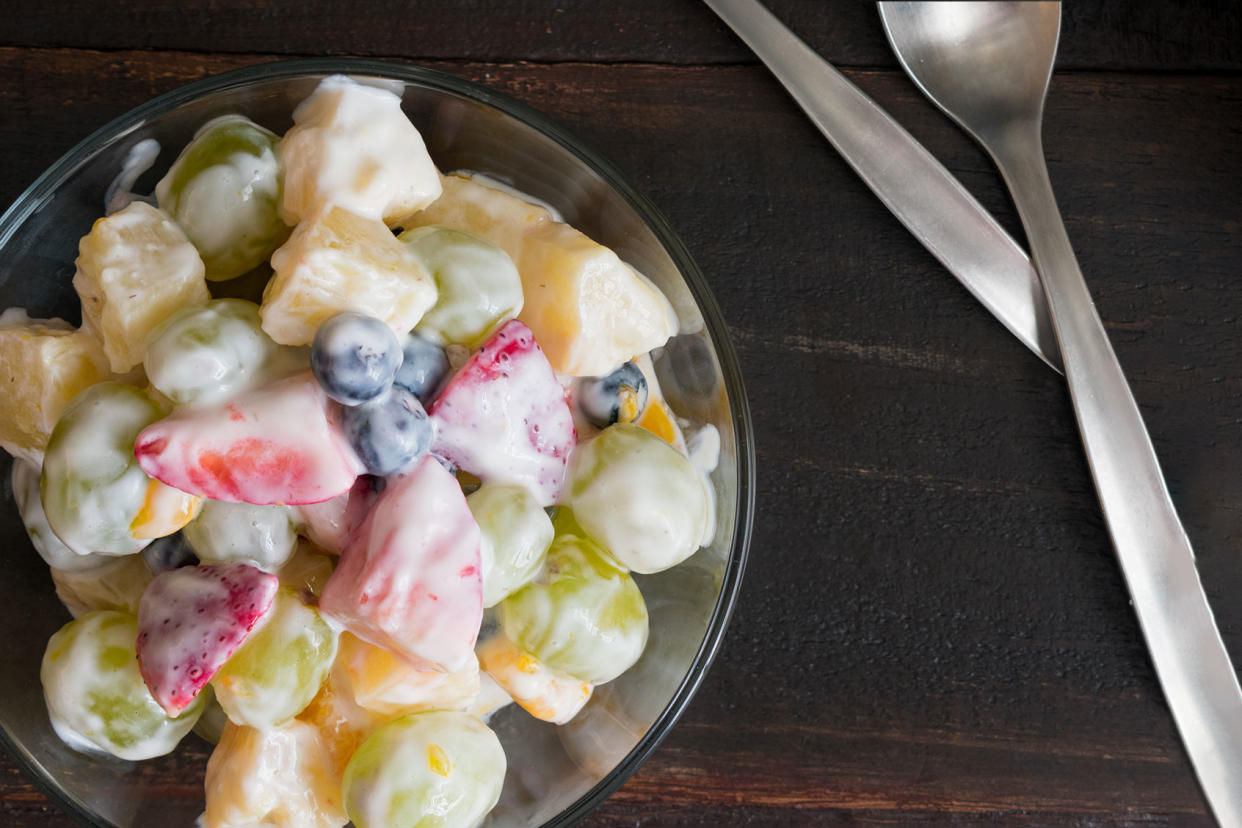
[319,457,483,672]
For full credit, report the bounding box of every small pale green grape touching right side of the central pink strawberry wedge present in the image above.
[466,484,553,607]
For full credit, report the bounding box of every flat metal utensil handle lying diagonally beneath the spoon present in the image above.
[705,0,1061,371]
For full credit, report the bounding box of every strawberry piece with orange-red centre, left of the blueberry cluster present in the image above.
[134,371,363,505]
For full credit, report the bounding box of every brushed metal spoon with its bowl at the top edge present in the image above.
[879,2,1242,826]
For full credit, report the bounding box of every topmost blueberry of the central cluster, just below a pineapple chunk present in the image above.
[311,310,401,406]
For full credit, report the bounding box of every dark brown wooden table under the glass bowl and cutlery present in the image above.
[0,0,1242,828]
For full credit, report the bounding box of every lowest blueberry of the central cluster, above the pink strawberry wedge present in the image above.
[340,386,431,475]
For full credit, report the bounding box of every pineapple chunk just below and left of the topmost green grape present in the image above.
[73,201,211,374]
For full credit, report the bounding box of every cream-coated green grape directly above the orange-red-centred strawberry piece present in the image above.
[143,299,308,405]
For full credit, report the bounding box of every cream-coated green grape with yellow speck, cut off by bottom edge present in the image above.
[343,711,505,828]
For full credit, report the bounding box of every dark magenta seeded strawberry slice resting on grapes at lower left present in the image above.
[137,564,279,716]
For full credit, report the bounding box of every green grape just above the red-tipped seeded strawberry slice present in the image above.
[400,227,522,348]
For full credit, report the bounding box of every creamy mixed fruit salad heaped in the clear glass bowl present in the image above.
[0,76,714,828]
